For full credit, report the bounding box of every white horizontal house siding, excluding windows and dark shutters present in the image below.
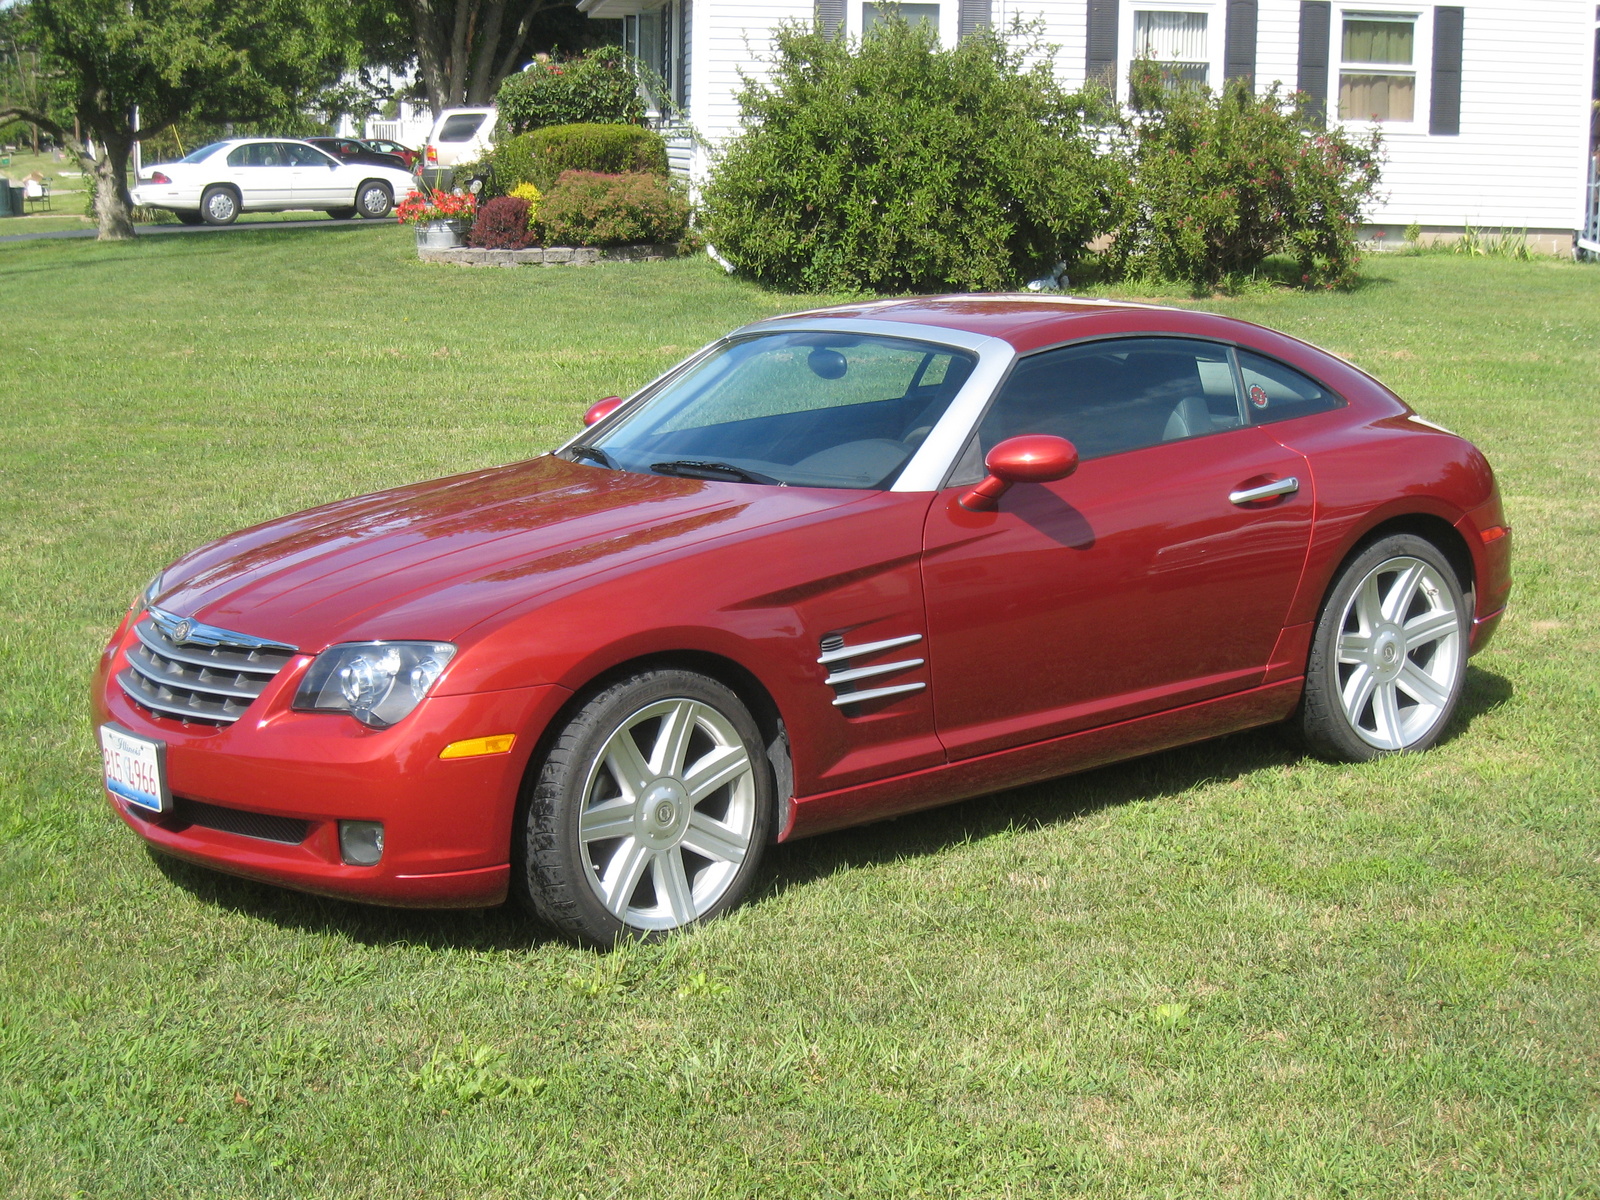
[668,0,1595,230]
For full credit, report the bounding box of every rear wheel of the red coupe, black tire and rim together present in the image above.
[1293,533,1470,762]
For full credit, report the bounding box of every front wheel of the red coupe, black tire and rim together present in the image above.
[512,669,774,947]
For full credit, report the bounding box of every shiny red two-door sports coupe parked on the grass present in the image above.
[94,296,1510,944]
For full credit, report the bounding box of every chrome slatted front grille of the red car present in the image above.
[117,605,299,725]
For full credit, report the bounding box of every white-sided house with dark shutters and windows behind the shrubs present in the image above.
[579,0,1600,253]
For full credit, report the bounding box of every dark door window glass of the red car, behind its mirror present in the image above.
[978,338,1243,459]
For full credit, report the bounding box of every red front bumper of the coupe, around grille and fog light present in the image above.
[93,626,571,907]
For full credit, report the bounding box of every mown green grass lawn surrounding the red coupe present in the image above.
[0,229,1600,1200]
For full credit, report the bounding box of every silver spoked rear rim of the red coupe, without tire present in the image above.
[1338,555,1462,750]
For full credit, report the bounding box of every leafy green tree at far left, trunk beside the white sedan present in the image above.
[0,0,354,238]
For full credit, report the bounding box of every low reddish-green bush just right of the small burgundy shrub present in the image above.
[539,171,690,246]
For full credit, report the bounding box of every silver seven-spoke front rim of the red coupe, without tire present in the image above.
[578,698,757,930]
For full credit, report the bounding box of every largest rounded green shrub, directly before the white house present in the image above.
[702,19,1118,291]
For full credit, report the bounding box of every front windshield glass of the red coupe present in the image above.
[566,331,976,488]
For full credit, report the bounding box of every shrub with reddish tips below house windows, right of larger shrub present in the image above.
[1106,64,1379,288]
